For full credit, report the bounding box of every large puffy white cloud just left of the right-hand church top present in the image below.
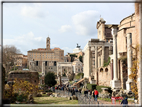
[72,10,99,35]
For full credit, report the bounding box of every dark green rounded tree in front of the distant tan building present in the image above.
[44,72,57,87]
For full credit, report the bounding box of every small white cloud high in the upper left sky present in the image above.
[21,3,48,18]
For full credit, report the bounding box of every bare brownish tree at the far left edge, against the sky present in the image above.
[3,45,21,74]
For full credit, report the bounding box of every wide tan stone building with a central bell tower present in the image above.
[28,37,64,74]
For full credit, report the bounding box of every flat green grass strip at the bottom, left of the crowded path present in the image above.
[34,97,78,104]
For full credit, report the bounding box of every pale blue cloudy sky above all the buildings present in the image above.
[3,3,134,55]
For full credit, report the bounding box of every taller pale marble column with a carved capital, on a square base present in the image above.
[111,26,121,89]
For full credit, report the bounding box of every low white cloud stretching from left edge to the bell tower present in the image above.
[3,32,46,54]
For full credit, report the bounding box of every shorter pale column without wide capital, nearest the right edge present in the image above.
[126,33,132,90]
